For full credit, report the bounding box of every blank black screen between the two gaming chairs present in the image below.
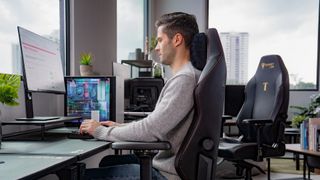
[224,85,245,117]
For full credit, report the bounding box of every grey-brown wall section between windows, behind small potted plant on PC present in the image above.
[70,0,117,75]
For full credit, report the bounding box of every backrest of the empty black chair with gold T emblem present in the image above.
[237,55,289,145]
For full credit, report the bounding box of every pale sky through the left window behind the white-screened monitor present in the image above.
[0,0,60,73]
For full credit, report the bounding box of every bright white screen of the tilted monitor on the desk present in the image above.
[18,27,65,93]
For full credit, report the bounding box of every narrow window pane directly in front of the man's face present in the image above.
[117,0,144,62]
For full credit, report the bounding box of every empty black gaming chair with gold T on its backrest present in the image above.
[218,55,289,179]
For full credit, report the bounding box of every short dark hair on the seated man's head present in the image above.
[155,12,199,47]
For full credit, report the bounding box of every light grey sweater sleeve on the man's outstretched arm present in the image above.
[93,74,196,141]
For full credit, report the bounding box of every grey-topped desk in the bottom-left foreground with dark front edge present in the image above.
[0,131,111,179]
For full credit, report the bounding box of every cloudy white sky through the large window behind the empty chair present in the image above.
[209,0,319,83]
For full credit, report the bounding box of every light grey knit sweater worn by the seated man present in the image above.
[93,62,200,179]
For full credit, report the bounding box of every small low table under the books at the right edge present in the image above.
[286,144,320,179]
